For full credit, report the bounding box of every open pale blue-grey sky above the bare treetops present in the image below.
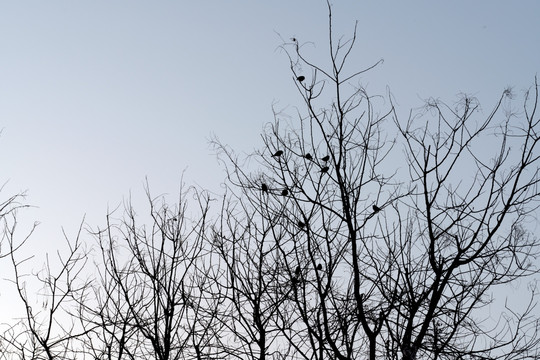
[0,0,540,318]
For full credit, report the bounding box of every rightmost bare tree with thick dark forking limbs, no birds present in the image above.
[381,85,540,359]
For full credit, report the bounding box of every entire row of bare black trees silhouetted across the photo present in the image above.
[0,2,540,360]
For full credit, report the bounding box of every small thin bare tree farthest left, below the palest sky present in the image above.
[2,217,88,359]
